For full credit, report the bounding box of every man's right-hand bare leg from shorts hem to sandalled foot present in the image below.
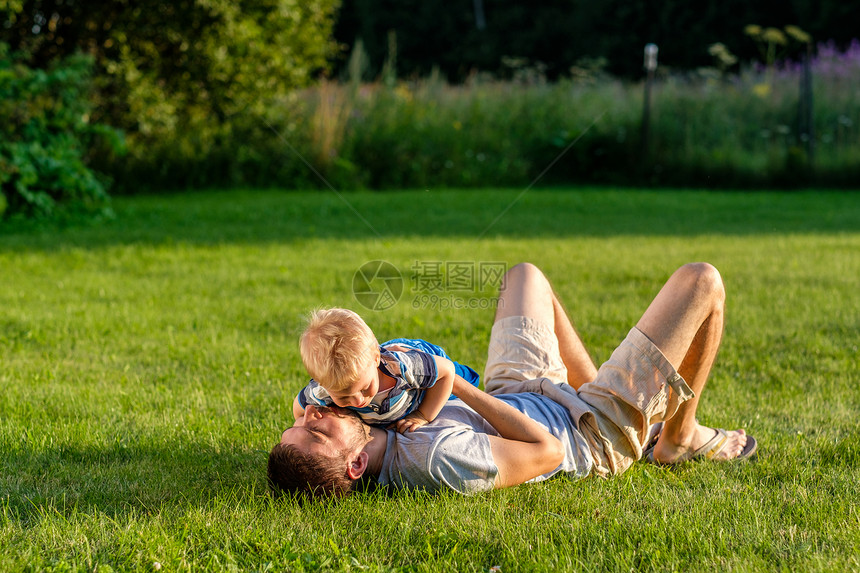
[636,263,747,463]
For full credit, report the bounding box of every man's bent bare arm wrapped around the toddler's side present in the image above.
[453,376,564,489]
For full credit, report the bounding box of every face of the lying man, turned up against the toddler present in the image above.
[281,404,370,458]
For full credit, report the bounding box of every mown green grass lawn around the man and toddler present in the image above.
[0,189,860,573]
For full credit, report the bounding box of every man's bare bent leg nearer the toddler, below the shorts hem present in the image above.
[496,263,597,389]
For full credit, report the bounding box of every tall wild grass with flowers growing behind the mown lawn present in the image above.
[102,41,860,194]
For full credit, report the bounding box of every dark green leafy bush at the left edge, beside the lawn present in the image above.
[0,44,121,217]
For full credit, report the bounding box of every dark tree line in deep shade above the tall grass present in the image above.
[335,0,860,81]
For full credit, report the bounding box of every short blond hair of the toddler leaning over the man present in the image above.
[299,308,379,390]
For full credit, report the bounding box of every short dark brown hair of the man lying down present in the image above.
[267,443,356,498]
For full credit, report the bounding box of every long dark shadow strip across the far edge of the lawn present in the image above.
[0,189,860,250]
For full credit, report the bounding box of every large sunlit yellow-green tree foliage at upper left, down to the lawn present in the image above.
[0,0,337,199]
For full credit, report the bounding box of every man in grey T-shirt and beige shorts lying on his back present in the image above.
[268,263,756,496]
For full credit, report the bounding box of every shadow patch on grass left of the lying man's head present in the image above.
[0,443,268,525]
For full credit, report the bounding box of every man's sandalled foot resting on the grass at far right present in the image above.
[649,423,756,464]
